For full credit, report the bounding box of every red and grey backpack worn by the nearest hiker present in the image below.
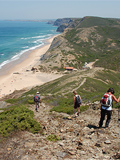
[100,93,112,107]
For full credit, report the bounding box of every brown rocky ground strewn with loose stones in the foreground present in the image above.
[0,103,120,160]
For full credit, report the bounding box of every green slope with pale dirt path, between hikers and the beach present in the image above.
[6,68,120,114]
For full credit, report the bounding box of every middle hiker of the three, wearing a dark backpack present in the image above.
[73,91,82,117]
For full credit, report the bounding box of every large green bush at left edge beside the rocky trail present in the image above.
[0,105,41,137]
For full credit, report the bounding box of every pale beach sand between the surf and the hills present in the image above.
[0,36,62,98]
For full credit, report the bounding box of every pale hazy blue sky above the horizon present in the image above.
[0,0,120,20]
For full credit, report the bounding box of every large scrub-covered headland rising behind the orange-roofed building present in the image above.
[40,17,120,71]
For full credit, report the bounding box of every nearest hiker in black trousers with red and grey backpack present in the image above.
[99,88,120,128]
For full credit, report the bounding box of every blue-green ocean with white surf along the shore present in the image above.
[0,21,58,69]
